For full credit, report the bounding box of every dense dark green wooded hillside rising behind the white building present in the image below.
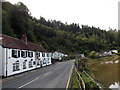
[2,2,120,54]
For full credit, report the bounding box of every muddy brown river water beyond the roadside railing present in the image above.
[90,60,119,87]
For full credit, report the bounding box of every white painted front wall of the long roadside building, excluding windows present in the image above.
[0,47,52,76]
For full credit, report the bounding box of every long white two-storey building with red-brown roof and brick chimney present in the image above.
[0,34,51,77]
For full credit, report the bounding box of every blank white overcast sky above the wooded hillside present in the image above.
[6,0,120,30]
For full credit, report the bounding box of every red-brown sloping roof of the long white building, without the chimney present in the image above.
[0,34,47,52]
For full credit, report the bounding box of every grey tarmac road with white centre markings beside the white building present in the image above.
[3,60,74,89]
